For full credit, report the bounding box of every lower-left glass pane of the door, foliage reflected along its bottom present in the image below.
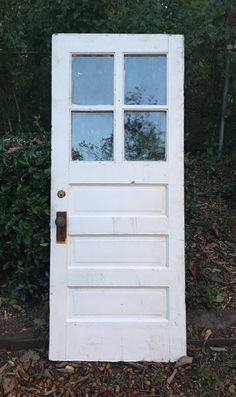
[72,112,113,161]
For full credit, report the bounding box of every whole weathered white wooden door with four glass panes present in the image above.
[49,34,186,361]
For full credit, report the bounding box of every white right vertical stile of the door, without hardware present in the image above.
[167,35,186,360]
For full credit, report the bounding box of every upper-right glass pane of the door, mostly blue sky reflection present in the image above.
[125,55,166,105]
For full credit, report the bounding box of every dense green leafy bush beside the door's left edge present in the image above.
[0,131,50,303]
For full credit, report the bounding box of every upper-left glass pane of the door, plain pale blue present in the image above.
[72,55,113,105]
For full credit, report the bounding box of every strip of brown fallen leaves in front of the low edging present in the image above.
[0,346,236,397]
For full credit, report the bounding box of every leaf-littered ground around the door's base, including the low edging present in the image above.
[0,296,236,397]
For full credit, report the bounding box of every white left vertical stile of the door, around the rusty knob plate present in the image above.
[50,35,70,360]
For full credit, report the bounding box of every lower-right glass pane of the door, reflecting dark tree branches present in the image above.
[125,112,166,161]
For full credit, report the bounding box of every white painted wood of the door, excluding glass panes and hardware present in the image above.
[49,34,186,361]
